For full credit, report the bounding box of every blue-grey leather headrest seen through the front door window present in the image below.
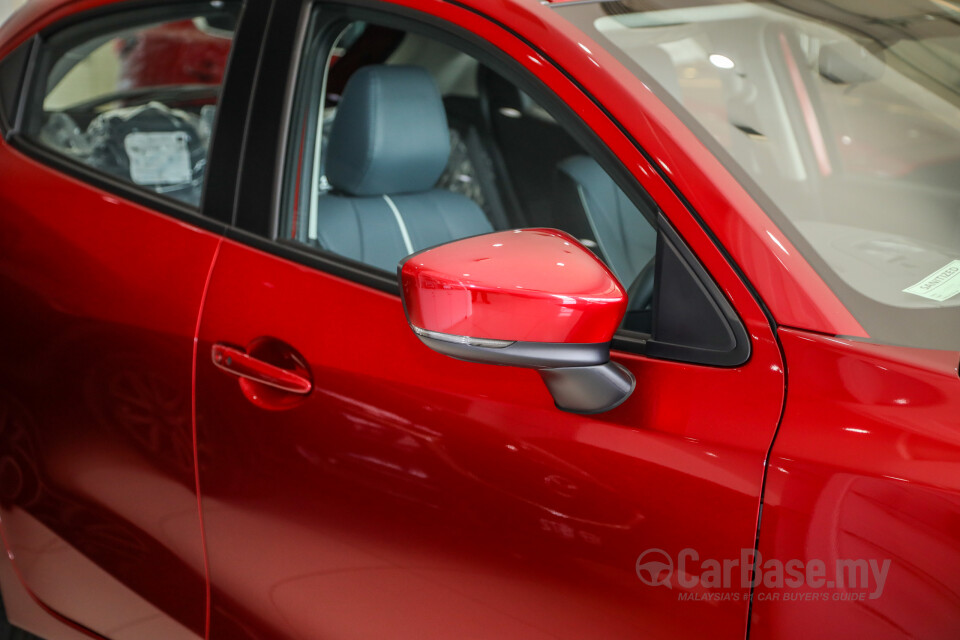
[327,65,450,196]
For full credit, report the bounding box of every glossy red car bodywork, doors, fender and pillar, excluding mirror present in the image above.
[0,0,960,640]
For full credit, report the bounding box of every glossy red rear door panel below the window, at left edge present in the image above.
[0,139,219,638]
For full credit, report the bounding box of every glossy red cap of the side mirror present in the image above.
[400,229,627,343]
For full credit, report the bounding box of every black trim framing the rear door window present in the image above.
[5,0,273,234]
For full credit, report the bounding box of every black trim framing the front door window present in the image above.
[226,0,752,367]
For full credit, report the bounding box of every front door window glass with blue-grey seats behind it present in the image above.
[279,16,657,332]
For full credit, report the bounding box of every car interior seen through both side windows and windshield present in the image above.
[27,3,960,358]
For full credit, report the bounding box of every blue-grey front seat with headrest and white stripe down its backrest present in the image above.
[317,65,493,271]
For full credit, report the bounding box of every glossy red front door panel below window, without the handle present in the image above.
[197,232,783,638]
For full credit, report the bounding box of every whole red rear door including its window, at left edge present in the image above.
[0,2,262,639]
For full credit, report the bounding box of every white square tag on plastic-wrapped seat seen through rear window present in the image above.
[123,131,193,184]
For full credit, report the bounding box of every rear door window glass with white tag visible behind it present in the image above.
[27,3,239,206]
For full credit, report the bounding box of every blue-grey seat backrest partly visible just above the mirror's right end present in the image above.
[558,156,657,287]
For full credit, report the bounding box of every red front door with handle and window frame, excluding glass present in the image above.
[196,2,785,638]
